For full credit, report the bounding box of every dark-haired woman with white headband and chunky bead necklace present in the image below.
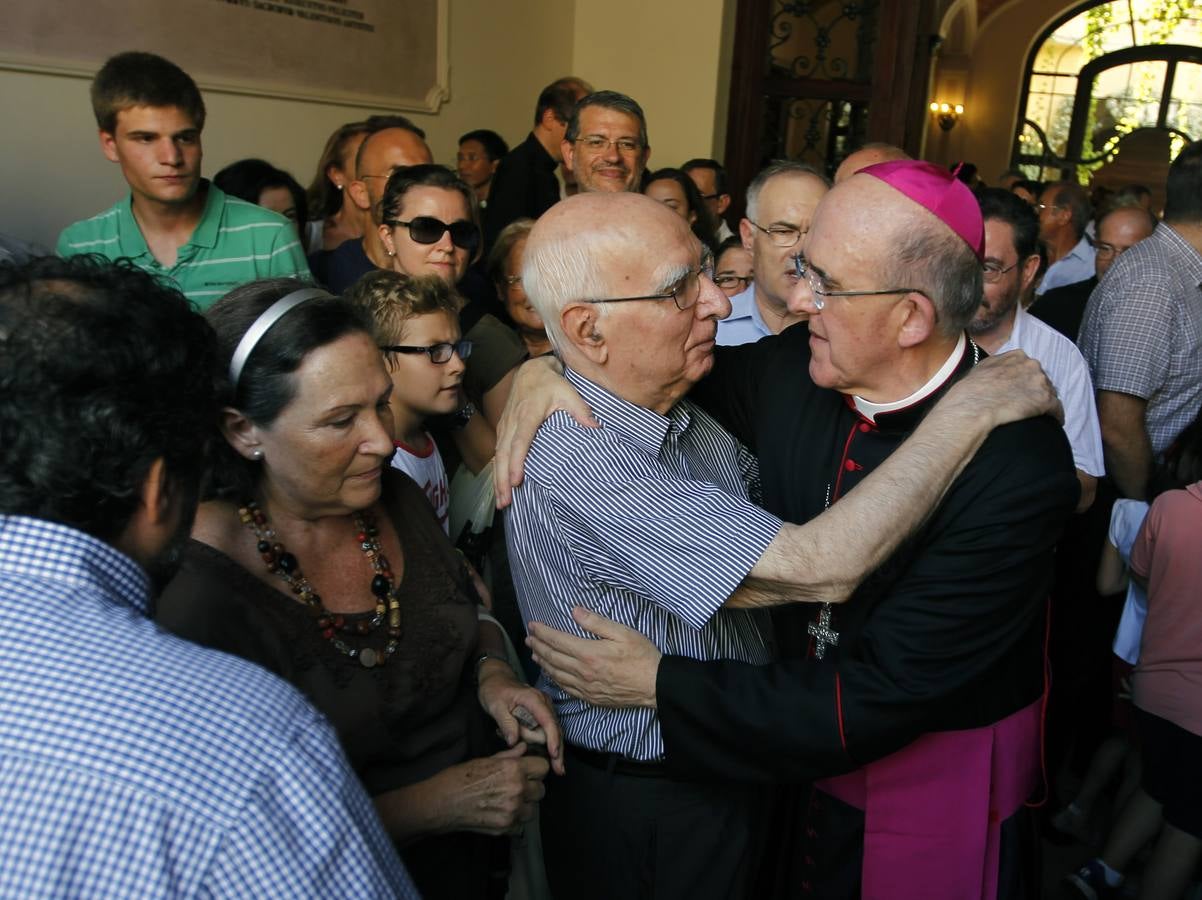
[159,279,563,898]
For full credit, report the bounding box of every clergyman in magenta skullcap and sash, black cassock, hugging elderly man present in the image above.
[499,161,1079,899]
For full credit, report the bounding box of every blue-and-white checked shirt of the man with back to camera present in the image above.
[0,515,417,899]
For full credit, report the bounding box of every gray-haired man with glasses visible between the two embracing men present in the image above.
[718,160,829,346]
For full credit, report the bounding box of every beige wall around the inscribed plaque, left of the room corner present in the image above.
[0,0,575,248]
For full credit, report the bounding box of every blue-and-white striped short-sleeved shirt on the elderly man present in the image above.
[505,369,781,761]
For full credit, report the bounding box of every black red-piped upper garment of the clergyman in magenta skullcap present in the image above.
[656,324,1079,781]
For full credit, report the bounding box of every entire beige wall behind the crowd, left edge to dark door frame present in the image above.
[0,0,734,248]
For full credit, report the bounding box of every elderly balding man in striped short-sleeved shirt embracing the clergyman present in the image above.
[501,193,1055,898]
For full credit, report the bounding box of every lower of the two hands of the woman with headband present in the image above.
[436,744,548,835]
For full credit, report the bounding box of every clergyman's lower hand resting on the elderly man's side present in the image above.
[526,607,662,709]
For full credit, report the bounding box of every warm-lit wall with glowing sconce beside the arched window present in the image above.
[924,0,1076,184]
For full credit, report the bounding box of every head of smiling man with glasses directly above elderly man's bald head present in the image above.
[563,90,651,193]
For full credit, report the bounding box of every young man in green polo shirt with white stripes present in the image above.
[58,52,309,309]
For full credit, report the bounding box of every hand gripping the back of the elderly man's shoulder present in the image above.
[493,357,597,509]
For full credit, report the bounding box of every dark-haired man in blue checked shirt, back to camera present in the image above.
[0,257,417,898]
